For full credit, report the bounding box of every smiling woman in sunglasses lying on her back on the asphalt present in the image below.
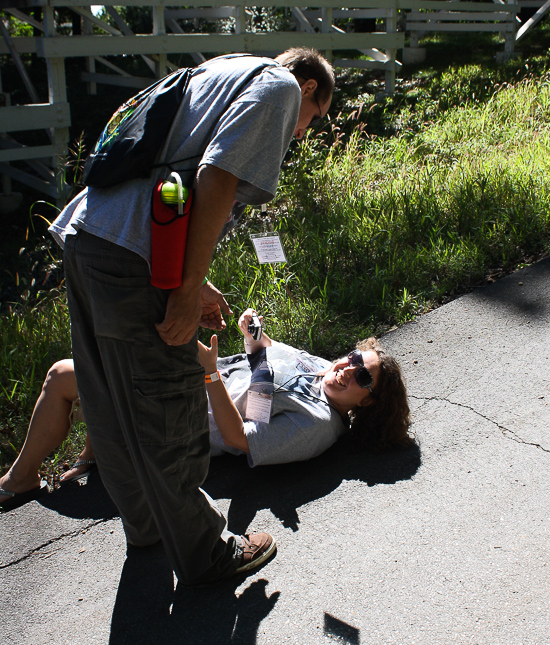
[0,309,413,510]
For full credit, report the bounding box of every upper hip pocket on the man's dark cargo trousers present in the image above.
[86,267,156,347]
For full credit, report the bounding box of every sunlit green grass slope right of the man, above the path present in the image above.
[208,72,550,356]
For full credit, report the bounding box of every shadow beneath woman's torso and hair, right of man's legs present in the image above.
[203,442,421,534]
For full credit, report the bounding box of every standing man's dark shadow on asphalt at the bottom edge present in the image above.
[109,542,279,645]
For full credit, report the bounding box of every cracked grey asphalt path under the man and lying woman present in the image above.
[0,259,550,645]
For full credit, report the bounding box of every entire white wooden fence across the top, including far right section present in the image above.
[0,0,550,207]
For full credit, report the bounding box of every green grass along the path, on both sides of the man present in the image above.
[0,28,550,484]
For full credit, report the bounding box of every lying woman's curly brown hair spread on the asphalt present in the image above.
[350,338,414,450]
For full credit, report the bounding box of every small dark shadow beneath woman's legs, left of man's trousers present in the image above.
[38,468,118,520]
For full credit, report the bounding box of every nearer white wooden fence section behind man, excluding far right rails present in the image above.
[0,0,404,204]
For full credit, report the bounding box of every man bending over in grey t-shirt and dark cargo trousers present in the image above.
[50,49,334,584]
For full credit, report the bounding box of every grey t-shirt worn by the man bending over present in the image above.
[49,55,301,263]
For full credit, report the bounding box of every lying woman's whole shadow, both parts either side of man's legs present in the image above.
[33,442,421,535]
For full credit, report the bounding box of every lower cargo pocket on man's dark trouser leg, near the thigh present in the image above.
[133,369,208,446]
